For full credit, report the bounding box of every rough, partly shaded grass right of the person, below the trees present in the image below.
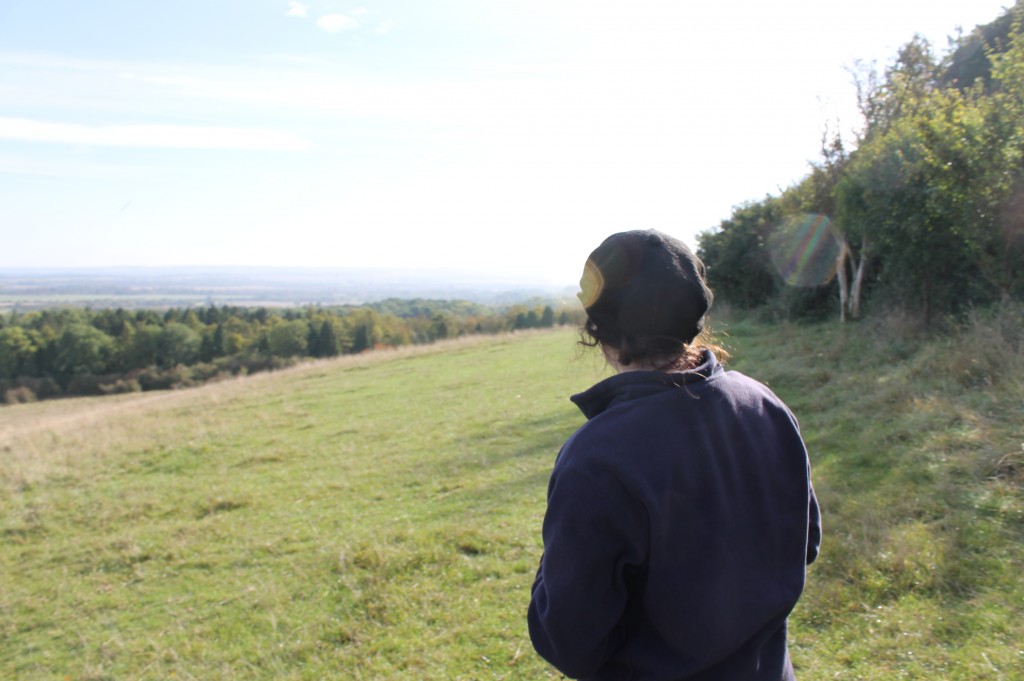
[726,307,1024,680]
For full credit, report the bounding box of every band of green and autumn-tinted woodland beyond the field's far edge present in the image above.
[0,299,583,403]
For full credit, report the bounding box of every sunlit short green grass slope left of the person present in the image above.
[0,331,602,679]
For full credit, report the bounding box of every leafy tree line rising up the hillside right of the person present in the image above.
[698,1,1024,326]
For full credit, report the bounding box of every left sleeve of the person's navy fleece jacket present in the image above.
[527,458,648,678]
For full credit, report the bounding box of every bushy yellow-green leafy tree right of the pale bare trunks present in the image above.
[838,47,1024,325]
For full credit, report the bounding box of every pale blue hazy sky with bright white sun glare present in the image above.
[0,0,1009,283]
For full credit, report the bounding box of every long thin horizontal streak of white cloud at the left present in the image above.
[0,118,309,152]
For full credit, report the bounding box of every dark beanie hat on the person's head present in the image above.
[579,229,713,343]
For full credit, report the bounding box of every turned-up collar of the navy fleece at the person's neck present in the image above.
[569,349,725,419]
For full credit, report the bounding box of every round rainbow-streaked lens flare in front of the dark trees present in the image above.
[768,214,840,287]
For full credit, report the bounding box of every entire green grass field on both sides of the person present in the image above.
[0,315,1024,680]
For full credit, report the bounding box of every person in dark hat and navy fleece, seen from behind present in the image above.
[527,230,821,681]
